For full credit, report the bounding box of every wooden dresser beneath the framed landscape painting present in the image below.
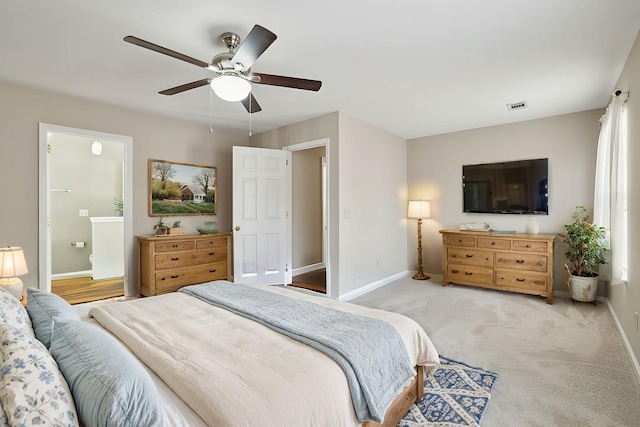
[136,233,231,296]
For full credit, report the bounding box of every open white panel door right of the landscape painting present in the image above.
[233,147,291,285]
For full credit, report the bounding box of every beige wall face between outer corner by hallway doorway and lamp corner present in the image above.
[339,114,407,295]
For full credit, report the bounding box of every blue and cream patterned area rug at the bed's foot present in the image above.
[398,356,498,427]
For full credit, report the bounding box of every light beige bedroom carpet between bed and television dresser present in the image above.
[351,275,640,427]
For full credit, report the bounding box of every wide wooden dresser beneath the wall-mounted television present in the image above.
[440,230,555,304]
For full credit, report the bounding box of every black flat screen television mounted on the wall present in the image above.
[462,159,549,215]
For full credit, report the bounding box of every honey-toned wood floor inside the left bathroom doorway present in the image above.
[51,276,124,304]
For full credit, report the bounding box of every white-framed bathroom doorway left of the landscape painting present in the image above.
[39,123,133,303]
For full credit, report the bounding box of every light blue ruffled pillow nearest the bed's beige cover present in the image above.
[51,319,163,427]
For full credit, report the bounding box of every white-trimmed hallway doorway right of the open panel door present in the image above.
[285,139,330,295]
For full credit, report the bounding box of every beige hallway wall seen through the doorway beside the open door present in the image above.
[291,147,326,274]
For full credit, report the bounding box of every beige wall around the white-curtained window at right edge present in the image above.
[609,33,640,372]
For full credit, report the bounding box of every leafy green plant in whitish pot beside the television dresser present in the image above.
[563,206,607,303]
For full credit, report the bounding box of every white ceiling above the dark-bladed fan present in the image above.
[0,0,640,139]
